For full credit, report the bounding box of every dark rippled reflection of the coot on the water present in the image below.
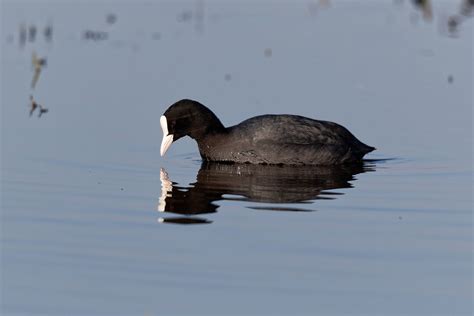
[158,161,375,224]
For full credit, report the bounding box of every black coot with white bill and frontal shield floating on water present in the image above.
[160,99,375,165]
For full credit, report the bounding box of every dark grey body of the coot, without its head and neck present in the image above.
[219,115,374,164]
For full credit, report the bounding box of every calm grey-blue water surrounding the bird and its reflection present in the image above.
[0,0,473,315]
